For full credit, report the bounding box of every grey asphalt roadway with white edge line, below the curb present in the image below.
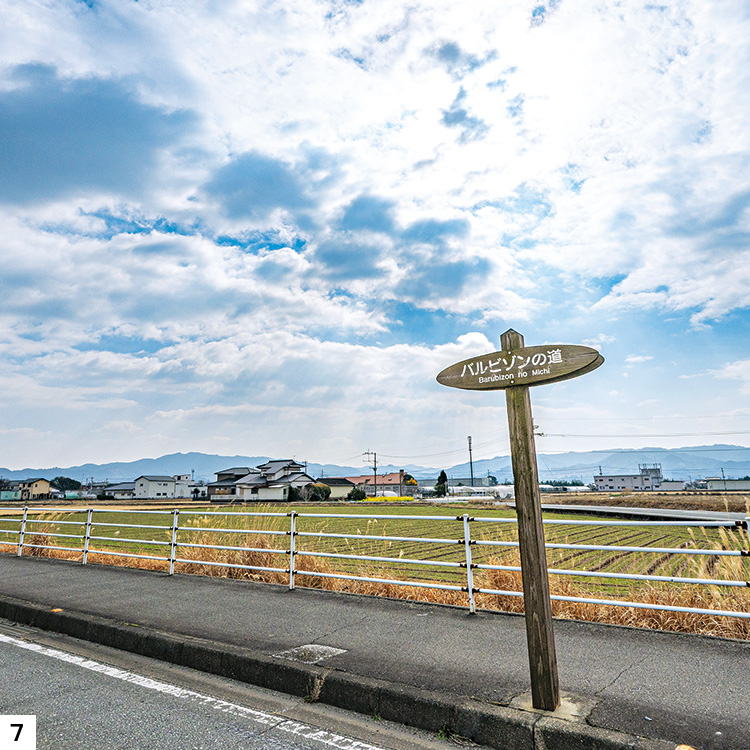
[0,621,458,750]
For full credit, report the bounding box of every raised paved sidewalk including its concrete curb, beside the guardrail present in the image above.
[0,555,750,750]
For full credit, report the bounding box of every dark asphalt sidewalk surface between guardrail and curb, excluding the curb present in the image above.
[0,556,750,750]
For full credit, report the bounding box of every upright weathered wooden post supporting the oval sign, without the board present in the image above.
[501,329,560,711]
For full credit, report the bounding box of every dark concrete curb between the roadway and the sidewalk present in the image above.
[0,596,675,750]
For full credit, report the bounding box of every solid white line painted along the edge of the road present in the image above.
[0,633,386,750]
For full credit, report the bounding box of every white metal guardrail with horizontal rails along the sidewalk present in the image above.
[0,506,750,619]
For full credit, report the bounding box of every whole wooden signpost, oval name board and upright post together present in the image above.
[437,329,604,711]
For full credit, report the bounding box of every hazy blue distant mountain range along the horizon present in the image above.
[0,445,750,484]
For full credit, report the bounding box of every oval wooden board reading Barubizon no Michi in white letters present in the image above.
[437,344,604,391]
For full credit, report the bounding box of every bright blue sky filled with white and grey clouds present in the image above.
[0,0,750,468]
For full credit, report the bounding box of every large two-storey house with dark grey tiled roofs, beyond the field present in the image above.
[208,459,314,502]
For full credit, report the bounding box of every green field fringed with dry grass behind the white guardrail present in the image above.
[0,497,750,639]
